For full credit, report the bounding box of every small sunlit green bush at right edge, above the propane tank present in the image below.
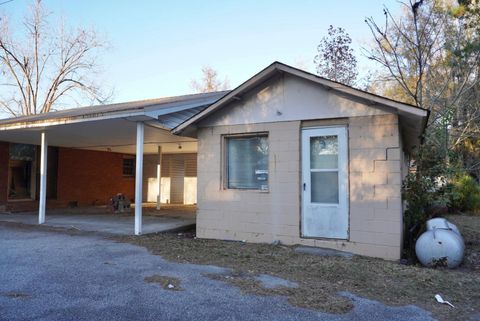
[449,174,480,212]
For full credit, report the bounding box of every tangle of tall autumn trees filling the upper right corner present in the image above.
[366,0,480,174]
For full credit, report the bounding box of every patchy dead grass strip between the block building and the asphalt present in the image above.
[115,216,480,320]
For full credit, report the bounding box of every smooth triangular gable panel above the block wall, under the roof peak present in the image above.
[199,76,389,127]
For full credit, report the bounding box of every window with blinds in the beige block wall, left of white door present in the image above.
[225,134,268,190]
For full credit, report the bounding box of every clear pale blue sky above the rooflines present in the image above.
[0,0,399,102]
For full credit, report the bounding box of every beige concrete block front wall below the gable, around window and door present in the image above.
[197,115,402,259]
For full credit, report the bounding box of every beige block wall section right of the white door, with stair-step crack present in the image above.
[349,114,402,259]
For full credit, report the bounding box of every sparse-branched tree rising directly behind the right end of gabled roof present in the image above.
[365,0,448,107]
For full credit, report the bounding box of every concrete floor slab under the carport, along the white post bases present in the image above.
[0,213,195,235]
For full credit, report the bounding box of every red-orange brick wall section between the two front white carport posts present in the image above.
[57,148,135,205]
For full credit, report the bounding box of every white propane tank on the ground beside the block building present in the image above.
[415,220,465,268]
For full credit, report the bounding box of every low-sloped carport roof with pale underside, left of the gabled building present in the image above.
[0,91,231,154]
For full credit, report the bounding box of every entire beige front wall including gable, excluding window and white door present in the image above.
[197,77,402,259]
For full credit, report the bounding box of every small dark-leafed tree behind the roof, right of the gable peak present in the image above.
[314,25,358,86]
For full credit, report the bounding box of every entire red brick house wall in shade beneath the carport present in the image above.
[0,142,196,211]
